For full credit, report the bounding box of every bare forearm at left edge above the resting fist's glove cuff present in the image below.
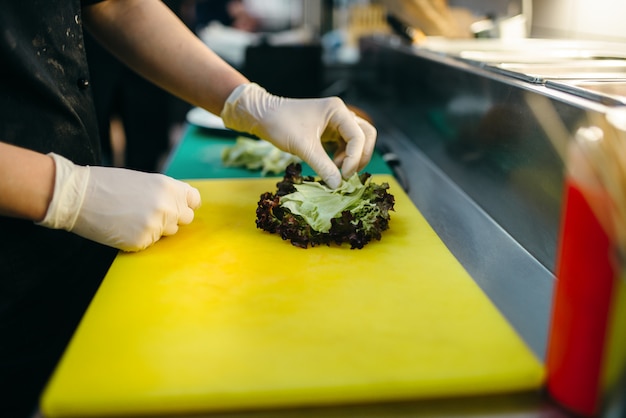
[0,142,55,221]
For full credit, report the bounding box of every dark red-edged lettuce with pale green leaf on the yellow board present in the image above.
[256,164,394,249]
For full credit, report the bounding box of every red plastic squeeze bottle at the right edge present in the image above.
[546,178,619,416]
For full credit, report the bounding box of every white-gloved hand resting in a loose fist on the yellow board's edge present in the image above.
[39,153,200,251]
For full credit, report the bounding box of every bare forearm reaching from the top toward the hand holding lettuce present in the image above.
[84,0,248,114]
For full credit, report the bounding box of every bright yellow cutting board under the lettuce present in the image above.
[42,175,544,418]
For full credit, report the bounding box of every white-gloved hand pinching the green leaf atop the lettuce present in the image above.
[221,83,376,188]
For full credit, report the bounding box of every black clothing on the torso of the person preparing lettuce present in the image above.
[0,0,117,418]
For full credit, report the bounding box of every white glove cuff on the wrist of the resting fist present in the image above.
[37,153,90,231]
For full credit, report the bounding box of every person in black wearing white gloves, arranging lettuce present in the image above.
[0,0,376,418]
